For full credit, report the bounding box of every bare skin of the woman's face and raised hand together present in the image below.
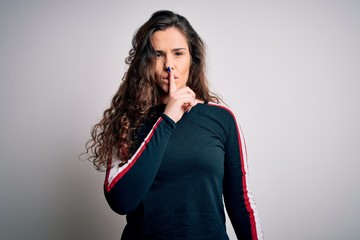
[151,27,201,122]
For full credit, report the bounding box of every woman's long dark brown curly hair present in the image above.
[85,10,220,171]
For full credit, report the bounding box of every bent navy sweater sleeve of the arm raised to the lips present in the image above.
[104,114,176,214]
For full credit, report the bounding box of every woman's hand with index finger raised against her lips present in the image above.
[164,68,196,123]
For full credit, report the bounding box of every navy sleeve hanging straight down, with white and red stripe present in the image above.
[223,109,263,239]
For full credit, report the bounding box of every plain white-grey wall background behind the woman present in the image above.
[0,0,360,240]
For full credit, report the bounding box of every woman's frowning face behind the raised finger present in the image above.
[151,27,191,93]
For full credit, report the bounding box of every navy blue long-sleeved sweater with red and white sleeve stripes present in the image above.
[104,103,262,240]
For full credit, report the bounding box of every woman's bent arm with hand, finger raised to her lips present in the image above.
[104,68,195,214]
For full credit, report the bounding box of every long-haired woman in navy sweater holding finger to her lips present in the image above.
[87,11,262,240]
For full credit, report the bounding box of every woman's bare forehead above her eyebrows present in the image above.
[151,27,188,49]
